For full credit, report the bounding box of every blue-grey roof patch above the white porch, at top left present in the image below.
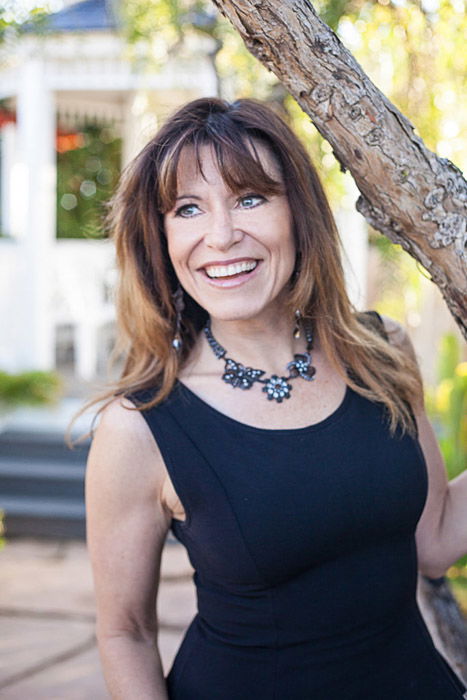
[33,0,118,32]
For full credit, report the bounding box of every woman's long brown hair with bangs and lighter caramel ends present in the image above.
[69,98,421,442]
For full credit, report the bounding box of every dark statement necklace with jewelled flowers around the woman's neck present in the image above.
[203,319,316,403]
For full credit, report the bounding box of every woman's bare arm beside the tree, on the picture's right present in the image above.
[384,317,467,578]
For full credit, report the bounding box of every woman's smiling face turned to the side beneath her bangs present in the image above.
[164,143,295,321]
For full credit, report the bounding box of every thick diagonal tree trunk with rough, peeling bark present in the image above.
[213,0,467,338]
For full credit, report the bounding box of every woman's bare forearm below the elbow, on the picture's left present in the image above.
[98,634,168,700]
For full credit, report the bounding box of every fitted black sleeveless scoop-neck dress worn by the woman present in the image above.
[130,383,467,700]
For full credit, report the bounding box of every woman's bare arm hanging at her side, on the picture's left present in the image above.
[86,399,170,700]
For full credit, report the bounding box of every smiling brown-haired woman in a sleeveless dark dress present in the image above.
[87,99,467,700]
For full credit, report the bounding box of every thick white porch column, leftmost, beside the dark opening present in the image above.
[12,56,56,370]
